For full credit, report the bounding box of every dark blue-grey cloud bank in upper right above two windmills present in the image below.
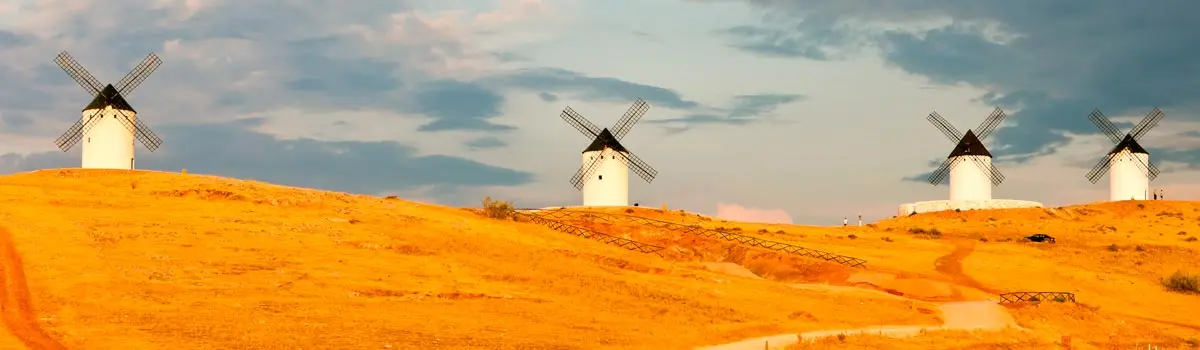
[710,0,1200,167]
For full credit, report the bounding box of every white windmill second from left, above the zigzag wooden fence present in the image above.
[562,98,659,206]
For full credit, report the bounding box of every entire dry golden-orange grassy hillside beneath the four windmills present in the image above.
[0,169,1200,349]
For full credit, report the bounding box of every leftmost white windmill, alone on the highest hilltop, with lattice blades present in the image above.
[54,52,162,170]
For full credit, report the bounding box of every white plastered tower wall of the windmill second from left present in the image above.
[582,149,629,206]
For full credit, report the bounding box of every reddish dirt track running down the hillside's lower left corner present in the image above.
[0,227,67,350]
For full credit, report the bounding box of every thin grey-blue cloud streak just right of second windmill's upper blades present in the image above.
[646,93,804,133]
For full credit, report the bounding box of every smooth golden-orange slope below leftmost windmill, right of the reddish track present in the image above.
[0,170,934,349]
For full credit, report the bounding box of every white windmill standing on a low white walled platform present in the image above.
[926,108,1006,201]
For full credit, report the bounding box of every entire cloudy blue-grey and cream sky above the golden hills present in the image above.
[0,0,1200,225]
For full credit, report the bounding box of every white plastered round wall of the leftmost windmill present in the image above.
[79,107,137,169]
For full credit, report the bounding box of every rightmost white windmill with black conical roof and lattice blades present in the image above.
[1087,107,1163,200]
